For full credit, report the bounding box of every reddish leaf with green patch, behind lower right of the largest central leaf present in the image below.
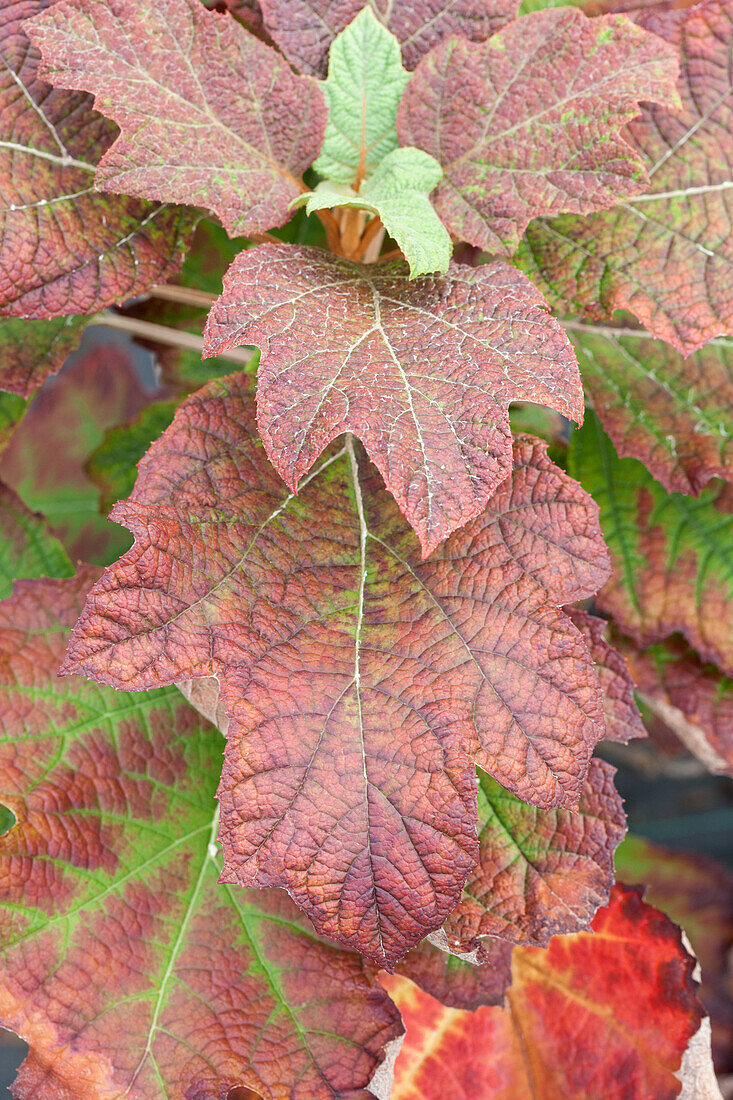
[444,759,626,950]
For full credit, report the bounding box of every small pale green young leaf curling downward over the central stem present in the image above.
[300,147,452,278]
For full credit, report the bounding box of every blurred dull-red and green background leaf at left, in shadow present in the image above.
[0,329,159,564]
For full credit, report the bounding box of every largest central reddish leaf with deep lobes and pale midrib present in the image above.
[66,374,608,965]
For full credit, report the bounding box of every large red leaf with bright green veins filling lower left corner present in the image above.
[0,570,402,1100]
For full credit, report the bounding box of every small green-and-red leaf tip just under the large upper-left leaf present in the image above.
[0,316,85,397]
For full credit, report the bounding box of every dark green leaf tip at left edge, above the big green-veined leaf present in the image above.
[0,482,74,600]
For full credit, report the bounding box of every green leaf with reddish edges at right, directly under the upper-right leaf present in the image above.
[569,326,733,494]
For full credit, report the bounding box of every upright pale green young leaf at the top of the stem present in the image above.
[314,8,409,185]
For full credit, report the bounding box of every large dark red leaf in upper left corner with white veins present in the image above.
[0,0,192,319]
